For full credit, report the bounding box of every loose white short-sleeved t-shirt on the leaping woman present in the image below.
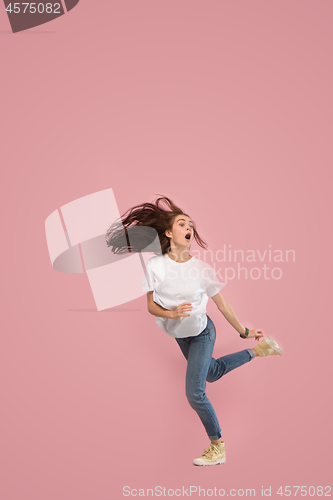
[142,253,225,338]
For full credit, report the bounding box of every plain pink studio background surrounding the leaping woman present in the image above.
[0,0,333,500]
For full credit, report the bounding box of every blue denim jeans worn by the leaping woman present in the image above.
[175,315,254,441]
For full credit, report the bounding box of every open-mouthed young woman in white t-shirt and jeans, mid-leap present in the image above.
[107,196,282,465]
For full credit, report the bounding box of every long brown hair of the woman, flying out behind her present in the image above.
[106,195,207,255]
